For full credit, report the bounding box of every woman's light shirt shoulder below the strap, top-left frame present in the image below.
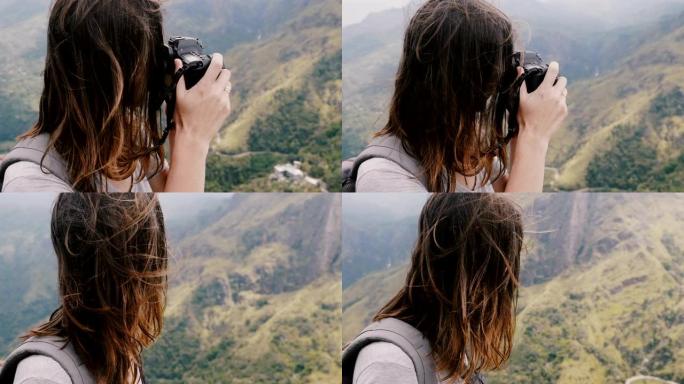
[2,161,73,193]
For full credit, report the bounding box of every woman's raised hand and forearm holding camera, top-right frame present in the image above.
[505,62,568,193]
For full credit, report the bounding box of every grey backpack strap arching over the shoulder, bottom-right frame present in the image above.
[342,319,438,384]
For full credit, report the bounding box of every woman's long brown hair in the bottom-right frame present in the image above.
[375,194,523,383]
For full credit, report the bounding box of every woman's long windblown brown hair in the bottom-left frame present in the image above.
[25,194,168,384]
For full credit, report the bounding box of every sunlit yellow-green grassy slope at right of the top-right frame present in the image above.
[550,19,684,189]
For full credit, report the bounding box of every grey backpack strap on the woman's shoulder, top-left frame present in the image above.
[0,134,71,189]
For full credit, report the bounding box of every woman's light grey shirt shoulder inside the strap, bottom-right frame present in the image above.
[354,342,418,384]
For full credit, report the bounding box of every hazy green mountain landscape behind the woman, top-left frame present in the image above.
[0,0,341,191]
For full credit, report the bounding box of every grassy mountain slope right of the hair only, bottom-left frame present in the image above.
[147,194,341,383]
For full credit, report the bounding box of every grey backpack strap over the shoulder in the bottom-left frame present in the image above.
[0,337,96,384]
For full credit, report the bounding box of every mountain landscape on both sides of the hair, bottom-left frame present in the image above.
[0,194,341,383]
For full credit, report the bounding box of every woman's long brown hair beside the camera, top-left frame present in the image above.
[22,0,164,192]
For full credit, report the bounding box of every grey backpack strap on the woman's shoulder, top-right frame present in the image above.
[342,136,426,192]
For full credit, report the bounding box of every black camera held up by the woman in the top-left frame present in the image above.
[165,37,211,89]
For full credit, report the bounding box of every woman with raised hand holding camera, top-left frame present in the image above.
[0,0,232,192]
